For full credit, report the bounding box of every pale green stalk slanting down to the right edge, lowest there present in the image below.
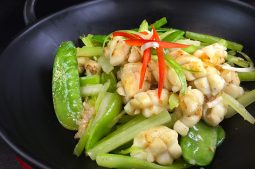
[222,92,255,124]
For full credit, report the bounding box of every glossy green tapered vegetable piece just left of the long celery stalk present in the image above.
[86,93,122,150]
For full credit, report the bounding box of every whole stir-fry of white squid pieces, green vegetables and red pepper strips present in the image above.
[52,18,255,169]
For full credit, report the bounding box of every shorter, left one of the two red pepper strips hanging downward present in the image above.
[139,48,151,89]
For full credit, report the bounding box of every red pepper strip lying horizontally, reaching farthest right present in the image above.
[125,39,189,48]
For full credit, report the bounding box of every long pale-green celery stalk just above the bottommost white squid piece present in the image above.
[87,111,171,160]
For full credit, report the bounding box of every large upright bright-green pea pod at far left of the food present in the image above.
[52,41,83,130]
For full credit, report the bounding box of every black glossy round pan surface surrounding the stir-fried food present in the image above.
[0,0,255,169]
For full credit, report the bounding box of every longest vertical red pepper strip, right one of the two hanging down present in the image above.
[152,25,165,98]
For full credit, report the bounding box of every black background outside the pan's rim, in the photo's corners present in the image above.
[0,0,255,169]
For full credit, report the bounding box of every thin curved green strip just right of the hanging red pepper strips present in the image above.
[165,55,187,93]
